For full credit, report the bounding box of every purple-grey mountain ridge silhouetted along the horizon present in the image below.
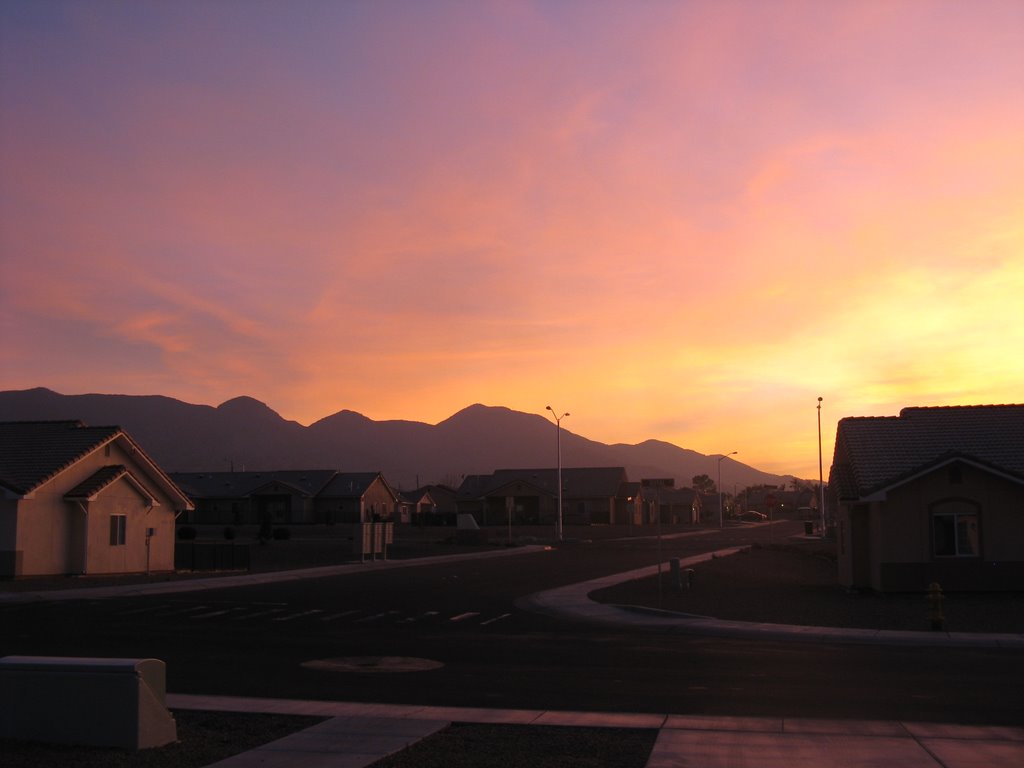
[0,388,792,488]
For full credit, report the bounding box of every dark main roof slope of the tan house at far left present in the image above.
[0,421,123,495]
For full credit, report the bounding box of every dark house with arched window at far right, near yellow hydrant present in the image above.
[828,406,1024,592]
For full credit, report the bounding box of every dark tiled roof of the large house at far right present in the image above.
[828,404,1024,499]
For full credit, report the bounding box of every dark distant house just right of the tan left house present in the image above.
[171,469,398,525]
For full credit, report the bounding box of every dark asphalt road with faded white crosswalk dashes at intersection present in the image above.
[0,528,1024,725]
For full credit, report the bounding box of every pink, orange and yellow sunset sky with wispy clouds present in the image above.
[0,0,1024,478]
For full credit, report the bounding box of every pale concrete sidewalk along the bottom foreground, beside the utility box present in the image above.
[167,693,1024,768]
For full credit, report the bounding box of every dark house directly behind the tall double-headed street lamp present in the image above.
[457,467,628,525]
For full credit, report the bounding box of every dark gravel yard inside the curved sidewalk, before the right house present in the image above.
[591,542,1024,633]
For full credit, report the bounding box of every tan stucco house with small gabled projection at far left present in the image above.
[0,421,193,577]
